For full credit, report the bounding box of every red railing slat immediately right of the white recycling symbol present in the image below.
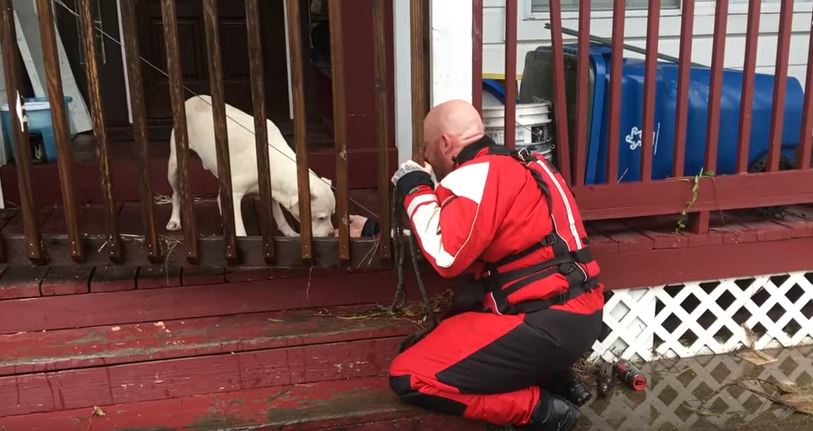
[641,0,661,182]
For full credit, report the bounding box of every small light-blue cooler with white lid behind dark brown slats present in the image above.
[0,96,73,163]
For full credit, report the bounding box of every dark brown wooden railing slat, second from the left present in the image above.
[37,0,85,263]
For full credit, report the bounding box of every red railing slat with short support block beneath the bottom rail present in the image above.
[689,0,728,234]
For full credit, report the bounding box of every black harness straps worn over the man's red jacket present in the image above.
[452,136,598,314]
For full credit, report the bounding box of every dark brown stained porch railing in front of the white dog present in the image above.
[0,0,418,266]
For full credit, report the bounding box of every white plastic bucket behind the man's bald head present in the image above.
[483,102,553,160]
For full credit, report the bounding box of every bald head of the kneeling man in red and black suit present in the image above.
[423,100,485,180]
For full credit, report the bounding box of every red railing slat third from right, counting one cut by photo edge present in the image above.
[737,0,762,174]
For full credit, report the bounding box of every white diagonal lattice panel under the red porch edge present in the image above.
[593,272,813,361]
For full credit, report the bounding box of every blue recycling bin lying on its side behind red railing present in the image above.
[520,45,804,184]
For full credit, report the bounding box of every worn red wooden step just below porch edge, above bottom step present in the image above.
[0,307,415,416]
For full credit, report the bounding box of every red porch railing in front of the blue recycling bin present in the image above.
[473,0,813,233]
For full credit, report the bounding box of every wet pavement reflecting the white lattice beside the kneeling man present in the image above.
[576,346,813,431]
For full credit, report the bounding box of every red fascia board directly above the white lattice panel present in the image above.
[596,233,813,289]
